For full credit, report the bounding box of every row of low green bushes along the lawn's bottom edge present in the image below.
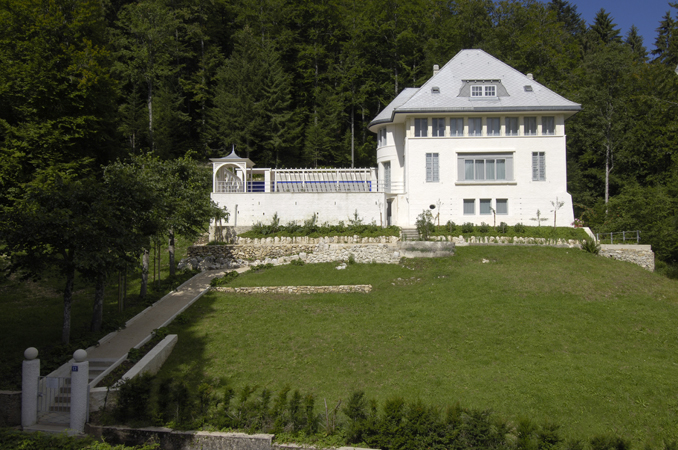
[107,376,664,450]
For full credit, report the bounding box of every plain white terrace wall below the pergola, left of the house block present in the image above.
[210,192,386,233]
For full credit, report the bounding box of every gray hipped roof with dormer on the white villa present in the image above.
[369,50,581,128]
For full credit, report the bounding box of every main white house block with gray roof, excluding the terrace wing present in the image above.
[370,50,580,226]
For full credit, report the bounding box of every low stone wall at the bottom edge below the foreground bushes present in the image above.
[85,424,378,450]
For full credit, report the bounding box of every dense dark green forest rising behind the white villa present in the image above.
[0,0,678,318]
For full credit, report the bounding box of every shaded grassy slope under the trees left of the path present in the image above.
[0,239,197,389]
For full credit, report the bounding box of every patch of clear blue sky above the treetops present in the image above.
[569,0,676,51]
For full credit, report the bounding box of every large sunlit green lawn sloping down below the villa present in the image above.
[160,246,678,445]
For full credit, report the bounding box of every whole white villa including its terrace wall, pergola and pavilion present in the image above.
[211,50,581,228]
